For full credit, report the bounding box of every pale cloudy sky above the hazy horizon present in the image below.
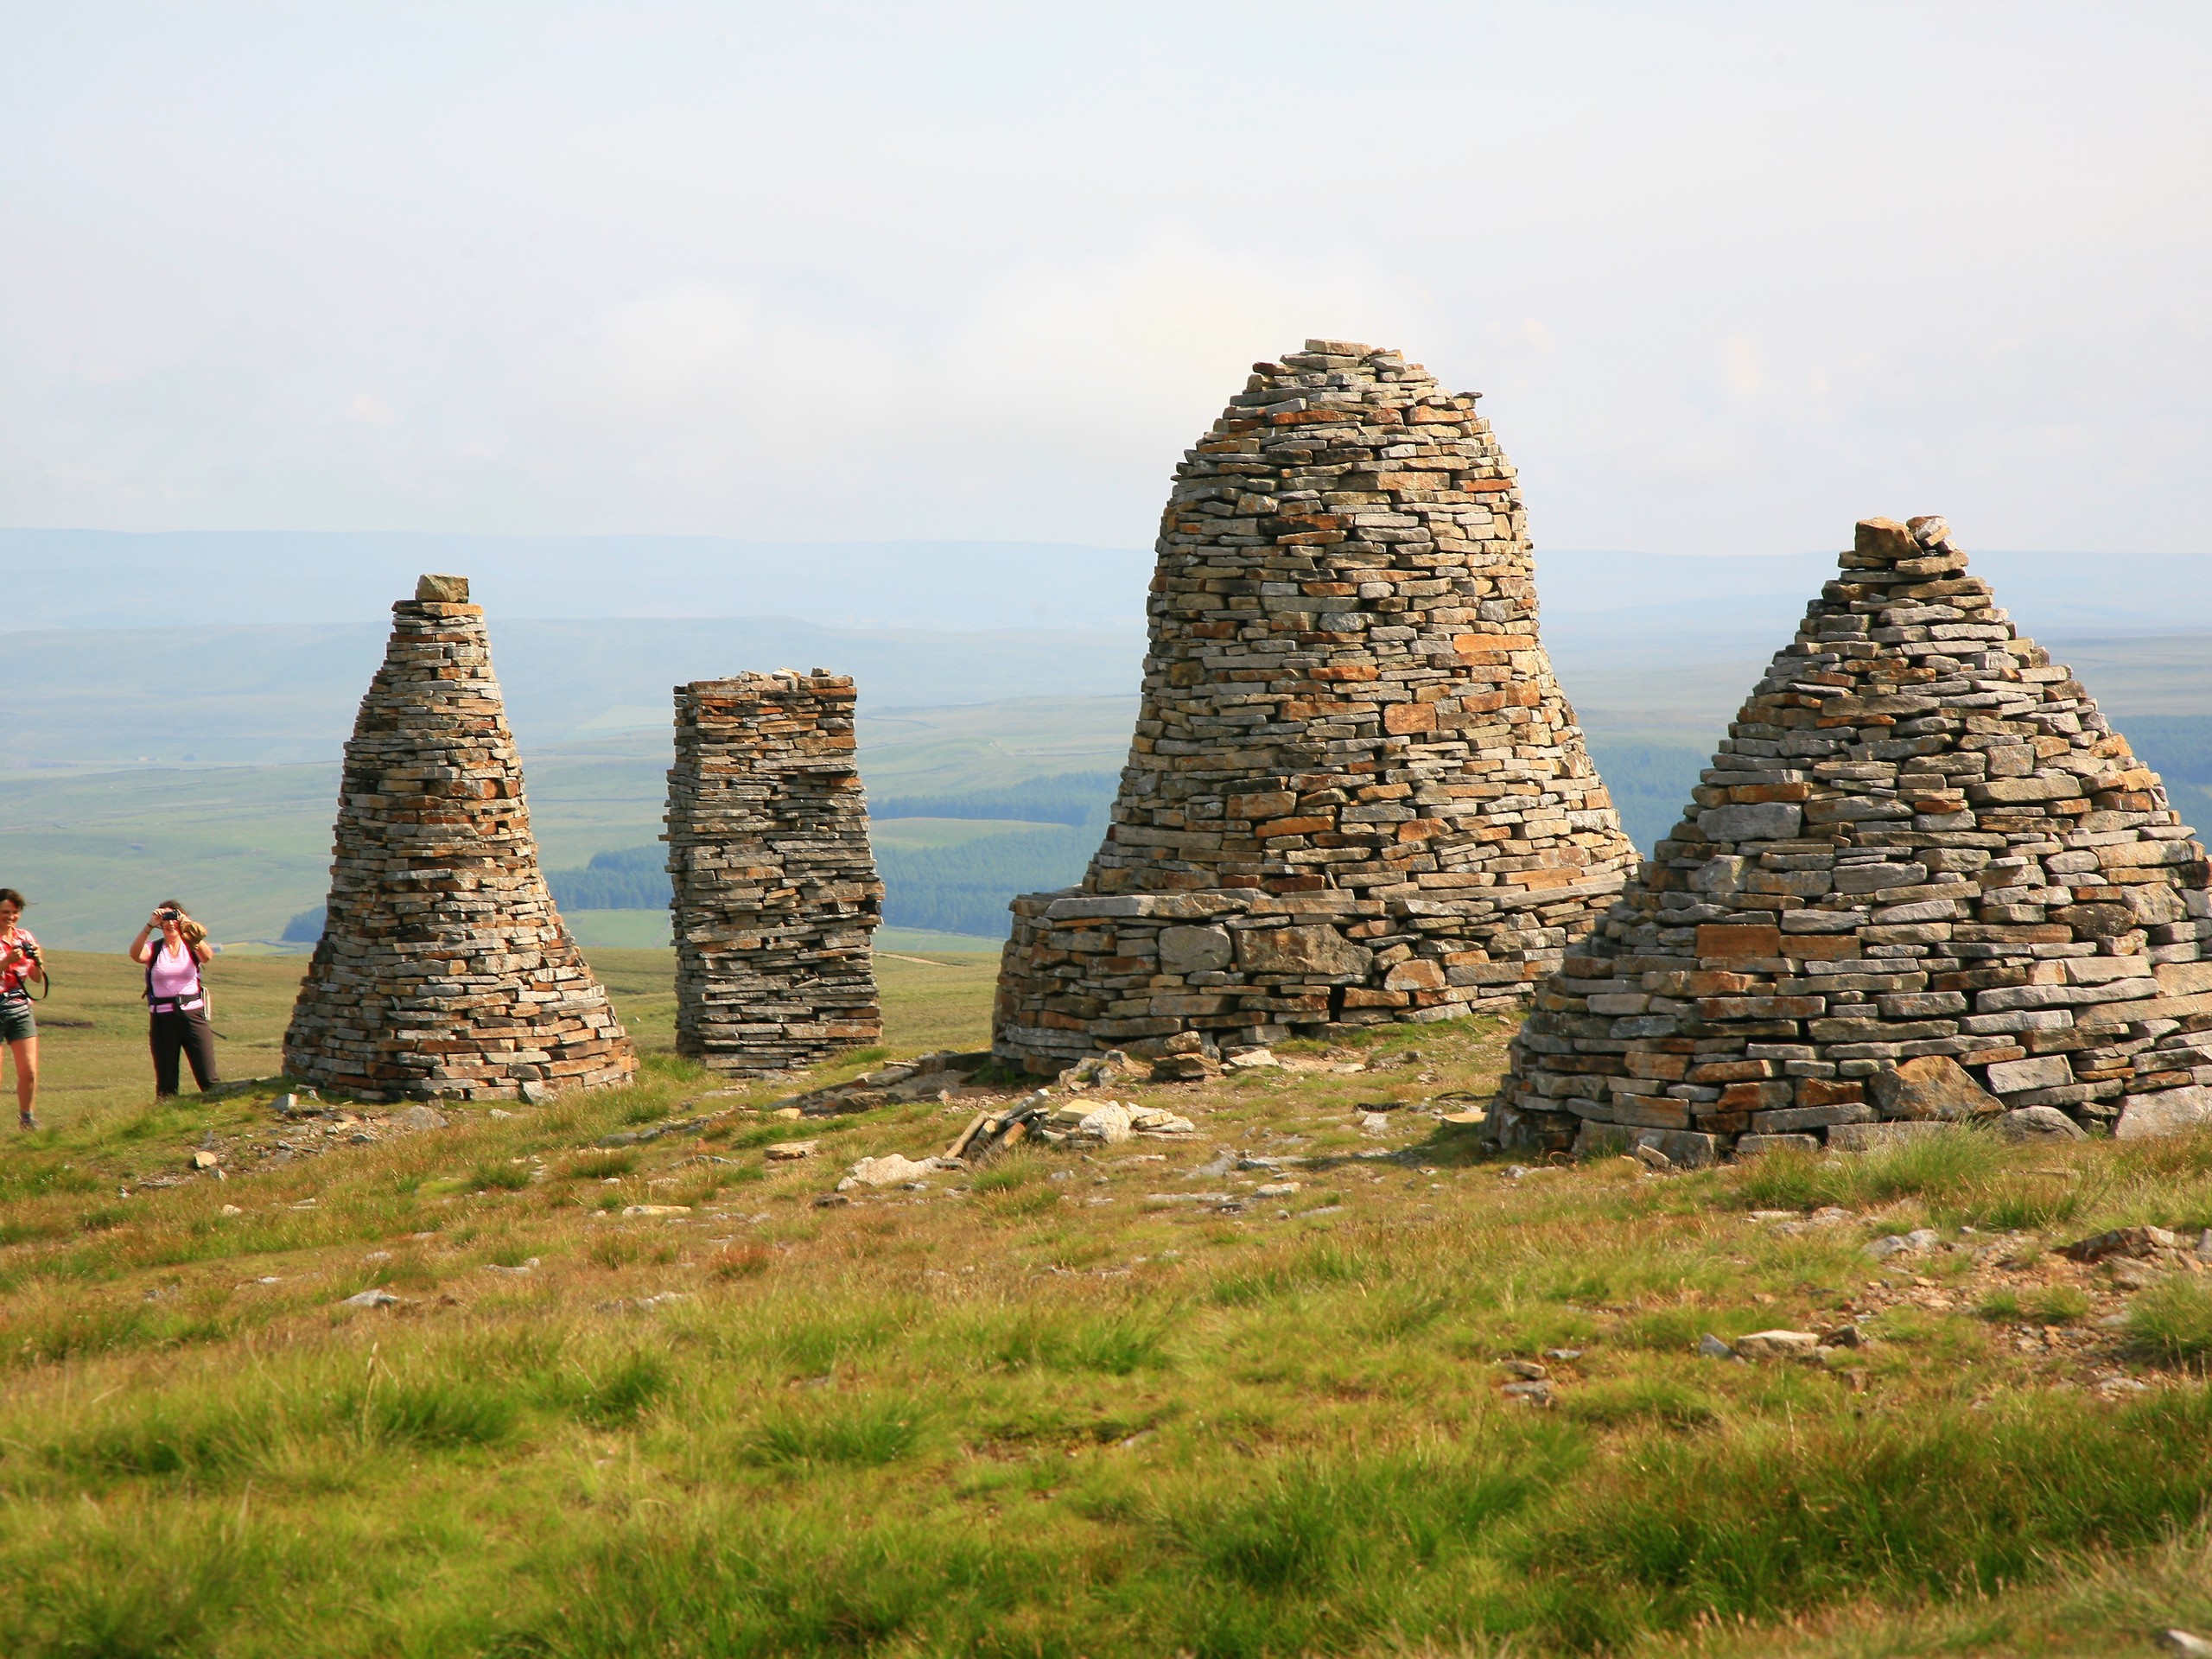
[0,0,2212,553]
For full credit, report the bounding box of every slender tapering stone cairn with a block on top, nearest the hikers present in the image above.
[283,575,637,1099]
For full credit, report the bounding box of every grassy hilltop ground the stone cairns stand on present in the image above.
[0,951,2212,1656]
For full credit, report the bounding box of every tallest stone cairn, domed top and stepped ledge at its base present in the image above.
[993,340,1635,1073]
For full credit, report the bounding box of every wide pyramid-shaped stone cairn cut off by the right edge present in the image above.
[1493,518,2212,1164]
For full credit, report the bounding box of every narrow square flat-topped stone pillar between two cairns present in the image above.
[668,668,882,1077]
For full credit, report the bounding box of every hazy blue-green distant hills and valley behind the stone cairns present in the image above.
[0,531,2212,949]
